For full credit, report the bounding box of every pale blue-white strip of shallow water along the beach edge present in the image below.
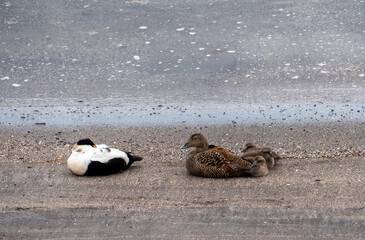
[0,98,365,127]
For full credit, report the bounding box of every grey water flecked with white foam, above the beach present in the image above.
[0,0,365,125]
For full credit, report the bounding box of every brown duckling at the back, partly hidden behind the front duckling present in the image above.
[241,143,281,169]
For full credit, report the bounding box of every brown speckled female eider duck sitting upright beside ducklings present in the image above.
[182,133,253,178]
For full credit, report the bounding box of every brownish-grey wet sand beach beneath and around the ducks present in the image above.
[0,122,365,239]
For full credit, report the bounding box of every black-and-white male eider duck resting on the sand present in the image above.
[67,139,142,176]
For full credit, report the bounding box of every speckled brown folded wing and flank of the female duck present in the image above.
[193,151,250,177]
